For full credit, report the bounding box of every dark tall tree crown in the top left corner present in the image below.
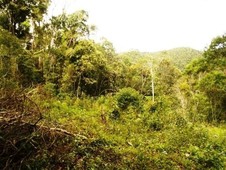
[0,0,50,38]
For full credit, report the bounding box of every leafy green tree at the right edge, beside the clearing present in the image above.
[186,35,226,121]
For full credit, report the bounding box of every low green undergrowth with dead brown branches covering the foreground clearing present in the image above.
[0,89,226,170]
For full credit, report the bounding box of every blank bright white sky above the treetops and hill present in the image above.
[48,0,226,52]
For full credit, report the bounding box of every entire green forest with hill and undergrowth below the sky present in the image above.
[0,0,226,170]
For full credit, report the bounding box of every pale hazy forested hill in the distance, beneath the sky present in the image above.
[118,47,203,70]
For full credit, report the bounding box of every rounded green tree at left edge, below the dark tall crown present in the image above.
[0,28,35,88]
